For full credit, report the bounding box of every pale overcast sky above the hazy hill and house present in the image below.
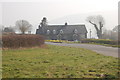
[0,0,119,34]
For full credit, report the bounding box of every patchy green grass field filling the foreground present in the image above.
[2,45,119,78]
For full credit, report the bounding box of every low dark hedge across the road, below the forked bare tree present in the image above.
[81,39,118,45]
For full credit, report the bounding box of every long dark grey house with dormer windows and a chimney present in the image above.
[36,23,87,41]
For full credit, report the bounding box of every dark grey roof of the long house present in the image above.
[43,25,87,34]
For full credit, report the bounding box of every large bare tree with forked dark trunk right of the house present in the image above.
[87,15,105,38]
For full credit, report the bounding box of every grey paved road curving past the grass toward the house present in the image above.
[45,42,120,57]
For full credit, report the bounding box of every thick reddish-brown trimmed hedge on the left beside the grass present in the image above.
[2,35,44,48]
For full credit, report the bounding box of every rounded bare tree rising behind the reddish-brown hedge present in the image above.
[15,20,32,34]
